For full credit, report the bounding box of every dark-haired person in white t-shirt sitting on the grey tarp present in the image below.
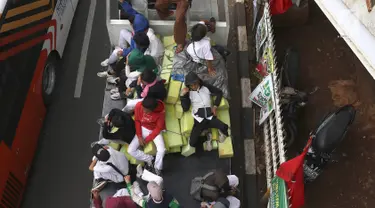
[186,18,216,74]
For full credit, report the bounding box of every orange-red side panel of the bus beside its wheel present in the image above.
[12,49,48,171]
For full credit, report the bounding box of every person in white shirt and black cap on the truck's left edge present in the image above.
[89,144,129,183]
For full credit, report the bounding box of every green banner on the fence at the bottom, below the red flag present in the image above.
[268,176,289,208]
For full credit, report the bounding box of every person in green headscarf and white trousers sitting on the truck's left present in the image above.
[111,49,158,100]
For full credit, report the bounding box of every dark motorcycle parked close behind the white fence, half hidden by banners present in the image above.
[280,48,310,148]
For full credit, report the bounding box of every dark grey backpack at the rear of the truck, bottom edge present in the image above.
[190,171,228,201]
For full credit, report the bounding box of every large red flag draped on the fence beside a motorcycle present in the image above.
[276,137,312,208]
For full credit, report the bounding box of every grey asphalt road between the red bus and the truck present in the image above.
[22,1,110,208]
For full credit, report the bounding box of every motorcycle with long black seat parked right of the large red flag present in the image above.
[303,105,356,183]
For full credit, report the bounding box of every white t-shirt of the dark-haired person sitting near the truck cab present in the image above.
[186,36,214,63]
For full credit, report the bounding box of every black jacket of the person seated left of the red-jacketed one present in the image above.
[102,108,135,144]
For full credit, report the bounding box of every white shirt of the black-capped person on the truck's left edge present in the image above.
[94,147,129,183]
